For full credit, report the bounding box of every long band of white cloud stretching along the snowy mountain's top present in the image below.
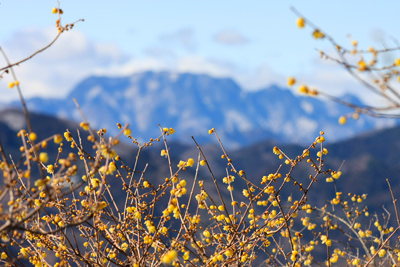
[0,25,376,108]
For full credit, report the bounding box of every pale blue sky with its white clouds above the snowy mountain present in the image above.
[0,0,400,100]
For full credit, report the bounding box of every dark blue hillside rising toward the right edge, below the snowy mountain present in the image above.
[230,127,400,209]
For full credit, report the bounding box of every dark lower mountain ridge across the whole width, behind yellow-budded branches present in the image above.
[0,110,400,214]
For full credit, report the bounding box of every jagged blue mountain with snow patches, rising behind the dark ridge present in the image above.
[12,72,393,146]
